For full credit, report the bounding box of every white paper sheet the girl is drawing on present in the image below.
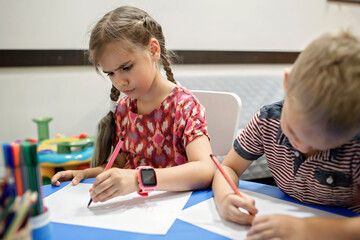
[44,183,191,235]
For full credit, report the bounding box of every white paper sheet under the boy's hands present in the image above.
[178,190,342,240]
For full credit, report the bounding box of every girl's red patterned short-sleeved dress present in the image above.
[115,85,209,169]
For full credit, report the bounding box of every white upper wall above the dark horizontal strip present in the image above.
[0,0,360,51]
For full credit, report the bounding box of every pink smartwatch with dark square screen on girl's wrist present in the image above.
[136,166,157,197]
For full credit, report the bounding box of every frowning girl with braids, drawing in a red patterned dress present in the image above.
[52,6,214,202]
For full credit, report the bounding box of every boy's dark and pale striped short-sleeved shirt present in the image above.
[234,101,360,213]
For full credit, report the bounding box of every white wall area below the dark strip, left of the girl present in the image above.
[0,66,111,176]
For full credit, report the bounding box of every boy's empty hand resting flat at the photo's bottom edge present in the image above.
[246,214,307,240]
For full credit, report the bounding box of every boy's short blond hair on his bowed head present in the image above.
[286,31,360,136]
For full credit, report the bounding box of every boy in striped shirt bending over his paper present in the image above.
[213,32,360,240]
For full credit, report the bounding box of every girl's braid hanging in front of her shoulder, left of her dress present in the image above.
[91,85,120,167]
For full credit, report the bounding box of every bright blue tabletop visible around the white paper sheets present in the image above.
[42,178,360,240]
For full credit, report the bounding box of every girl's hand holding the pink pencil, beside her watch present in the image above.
[89,168,140,202]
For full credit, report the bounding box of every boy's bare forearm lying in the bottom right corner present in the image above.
[304,217,360,240]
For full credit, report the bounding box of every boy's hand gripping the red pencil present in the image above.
[216,193,258,225]
